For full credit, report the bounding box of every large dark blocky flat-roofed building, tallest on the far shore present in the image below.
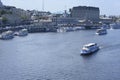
[70,6,100,21]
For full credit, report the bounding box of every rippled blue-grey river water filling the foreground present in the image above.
[0,30,120,80]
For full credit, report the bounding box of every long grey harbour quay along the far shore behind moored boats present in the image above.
[0,23,103,33]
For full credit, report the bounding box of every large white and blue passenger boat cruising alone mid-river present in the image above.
[81,43,99,55]
